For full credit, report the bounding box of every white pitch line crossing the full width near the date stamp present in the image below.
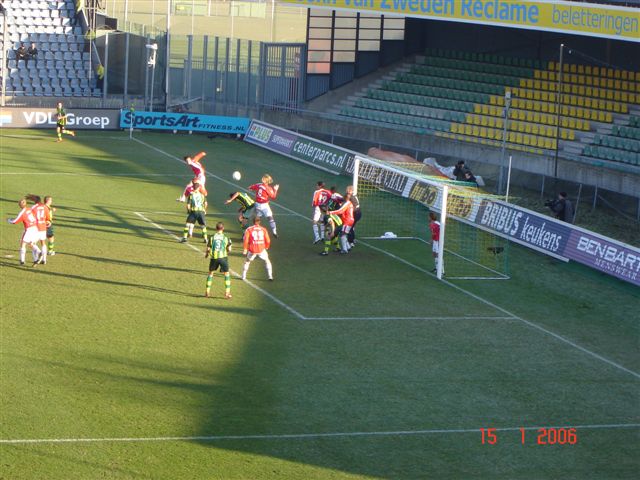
[0,423,640,445]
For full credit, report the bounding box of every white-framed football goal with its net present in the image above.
[353,156,509,279]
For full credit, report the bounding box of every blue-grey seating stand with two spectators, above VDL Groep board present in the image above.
[2,0,96,97]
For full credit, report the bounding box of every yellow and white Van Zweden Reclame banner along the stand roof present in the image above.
[281,0,640,42]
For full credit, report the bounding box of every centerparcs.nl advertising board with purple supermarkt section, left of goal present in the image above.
[244,120,356,174]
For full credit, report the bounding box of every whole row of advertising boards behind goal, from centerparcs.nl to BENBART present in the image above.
[245,120,640,286]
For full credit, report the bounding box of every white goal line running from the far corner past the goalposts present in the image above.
[134,138,640,379]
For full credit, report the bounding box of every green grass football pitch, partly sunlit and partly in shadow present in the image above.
[0,129,640,480]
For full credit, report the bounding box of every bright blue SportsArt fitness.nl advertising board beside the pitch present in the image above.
[120,110,249,135]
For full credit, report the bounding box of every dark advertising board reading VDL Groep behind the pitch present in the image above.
[0,107,120,130]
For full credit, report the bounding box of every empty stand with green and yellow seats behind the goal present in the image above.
[339,49,640,165]
